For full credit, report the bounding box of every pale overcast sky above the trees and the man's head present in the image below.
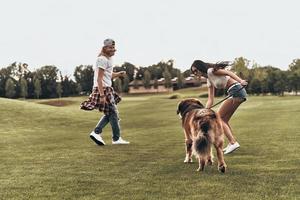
[0,0,300,74]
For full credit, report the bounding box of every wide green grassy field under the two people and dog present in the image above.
[0,90,300,200]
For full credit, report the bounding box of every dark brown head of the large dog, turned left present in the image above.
[177,98,204,117]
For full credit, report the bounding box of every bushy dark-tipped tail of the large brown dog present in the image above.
[193,118,213,156]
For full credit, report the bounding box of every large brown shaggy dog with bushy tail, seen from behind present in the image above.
[177,98,226,173]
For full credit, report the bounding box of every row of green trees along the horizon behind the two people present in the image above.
[0,57,300,99]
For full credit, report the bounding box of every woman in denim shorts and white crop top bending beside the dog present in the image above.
[191,60,248,154]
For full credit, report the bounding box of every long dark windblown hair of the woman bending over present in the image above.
[191,60,229,74]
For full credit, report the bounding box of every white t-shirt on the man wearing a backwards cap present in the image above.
[93,56,113,87]
